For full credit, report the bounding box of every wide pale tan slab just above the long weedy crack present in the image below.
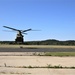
[0,56,75,67]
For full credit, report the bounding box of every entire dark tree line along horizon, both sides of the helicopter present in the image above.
[0,39,75,45]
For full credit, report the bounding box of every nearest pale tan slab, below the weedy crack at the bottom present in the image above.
[0,67,75,75]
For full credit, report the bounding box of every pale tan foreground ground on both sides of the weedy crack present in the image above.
[0,56,75,75]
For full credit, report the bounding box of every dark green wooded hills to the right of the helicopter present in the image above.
[24,39,75,45]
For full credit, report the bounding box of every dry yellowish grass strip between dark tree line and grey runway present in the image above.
[0,44,75,49]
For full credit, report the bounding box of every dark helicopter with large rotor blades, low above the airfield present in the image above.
[3,26,32,43]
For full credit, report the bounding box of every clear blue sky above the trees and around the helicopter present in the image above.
[0,0,75,41]
